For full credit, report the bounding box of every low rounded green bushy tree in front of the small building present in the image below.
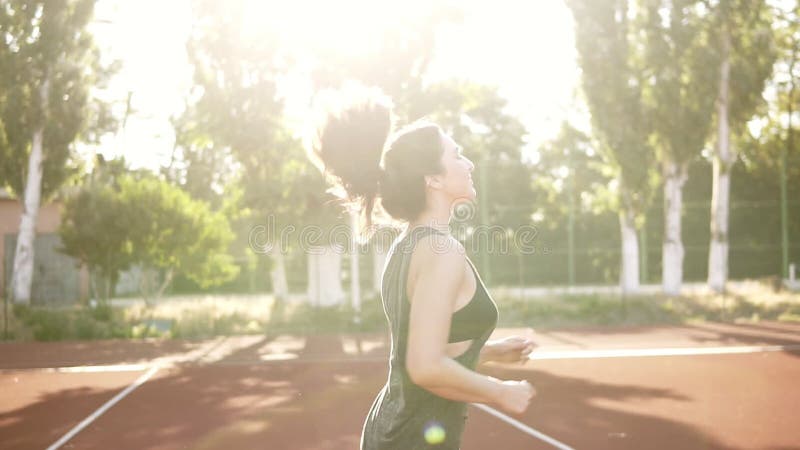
[59,170,237,303]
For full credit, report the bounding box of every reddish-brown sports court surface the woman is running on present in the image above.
[0,324,800,450]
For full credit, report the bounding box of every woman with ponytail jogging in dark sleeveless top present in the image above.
[310,86,534,450]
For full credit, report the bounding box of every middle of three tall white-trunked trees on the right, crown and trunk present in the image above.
[640,0,718,295]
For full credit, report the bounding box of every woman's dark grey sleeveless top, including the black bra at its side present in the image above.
[361,227,497,450]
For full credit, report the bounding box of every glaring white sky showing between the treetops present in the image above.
[86,0,583,169]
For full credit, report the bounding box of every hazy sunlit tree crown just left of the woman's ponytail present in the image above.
[173,1,336,253]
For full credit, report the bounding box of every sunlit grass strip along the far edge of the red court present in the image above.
[0,282,800,341]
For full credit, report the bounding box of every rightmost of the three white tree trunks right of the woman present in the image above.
[708,29,736,292]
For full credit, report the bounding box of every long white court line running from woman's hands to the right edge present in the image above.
[529,344,800,360]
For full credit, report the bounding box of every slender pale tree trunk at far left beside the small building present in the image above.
[11,75,50,304]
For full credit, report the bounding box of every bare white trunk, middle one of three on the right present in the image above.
[661,162,687,295]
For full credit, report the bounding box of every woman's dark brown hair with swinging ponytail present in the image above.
[309,86,444,237]
